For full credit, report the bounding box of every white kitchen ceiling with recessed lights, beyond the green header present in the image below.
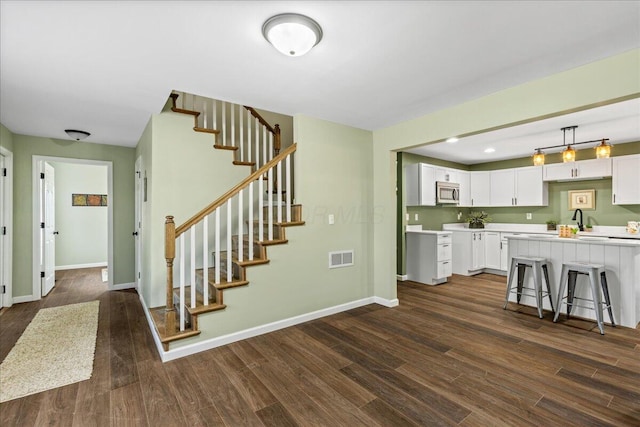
[405,98,640,165]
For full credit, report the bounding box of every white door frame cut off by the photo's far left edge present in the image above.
[0,147,13,308]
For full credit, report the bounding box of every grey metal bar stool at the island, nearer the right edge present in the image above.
[553,261,616,335]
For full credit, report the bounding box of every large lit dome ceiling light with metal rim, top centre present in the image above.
[262,13,322,56]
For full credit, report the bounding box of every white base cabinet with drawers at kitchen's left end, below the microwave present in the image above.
[406,231,452,285]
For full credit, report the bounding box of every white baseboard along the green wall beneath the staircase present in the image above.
[156,297,398,362]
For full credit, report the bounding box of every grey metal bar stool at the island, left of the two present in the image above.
[502,257,555,319]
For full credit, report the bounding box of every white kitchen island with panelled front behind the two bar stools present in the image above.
[505,235,640,328]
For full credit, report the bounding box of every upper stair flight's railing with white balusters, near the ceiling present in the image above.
[170,91,281,174]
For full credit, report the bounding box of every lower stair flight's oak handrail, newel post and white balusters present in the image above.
[159,144,304,349]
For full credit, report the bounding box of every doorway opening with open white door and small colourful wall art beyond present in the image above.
[32,156,113,300]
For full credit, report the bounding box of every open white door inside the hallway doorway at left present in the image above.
[42,162,56,296]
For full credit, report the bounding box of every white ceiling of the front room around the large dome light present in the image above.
[0,0,640,150]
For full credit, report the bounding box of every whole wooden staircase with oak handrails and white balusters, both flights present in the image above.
[150,92,304,351]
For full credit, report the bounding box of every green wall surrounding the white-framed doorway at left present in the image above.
[8,134,135,297]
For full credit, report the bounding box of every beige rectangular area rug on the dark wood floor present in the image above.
[0,301,100,402]
